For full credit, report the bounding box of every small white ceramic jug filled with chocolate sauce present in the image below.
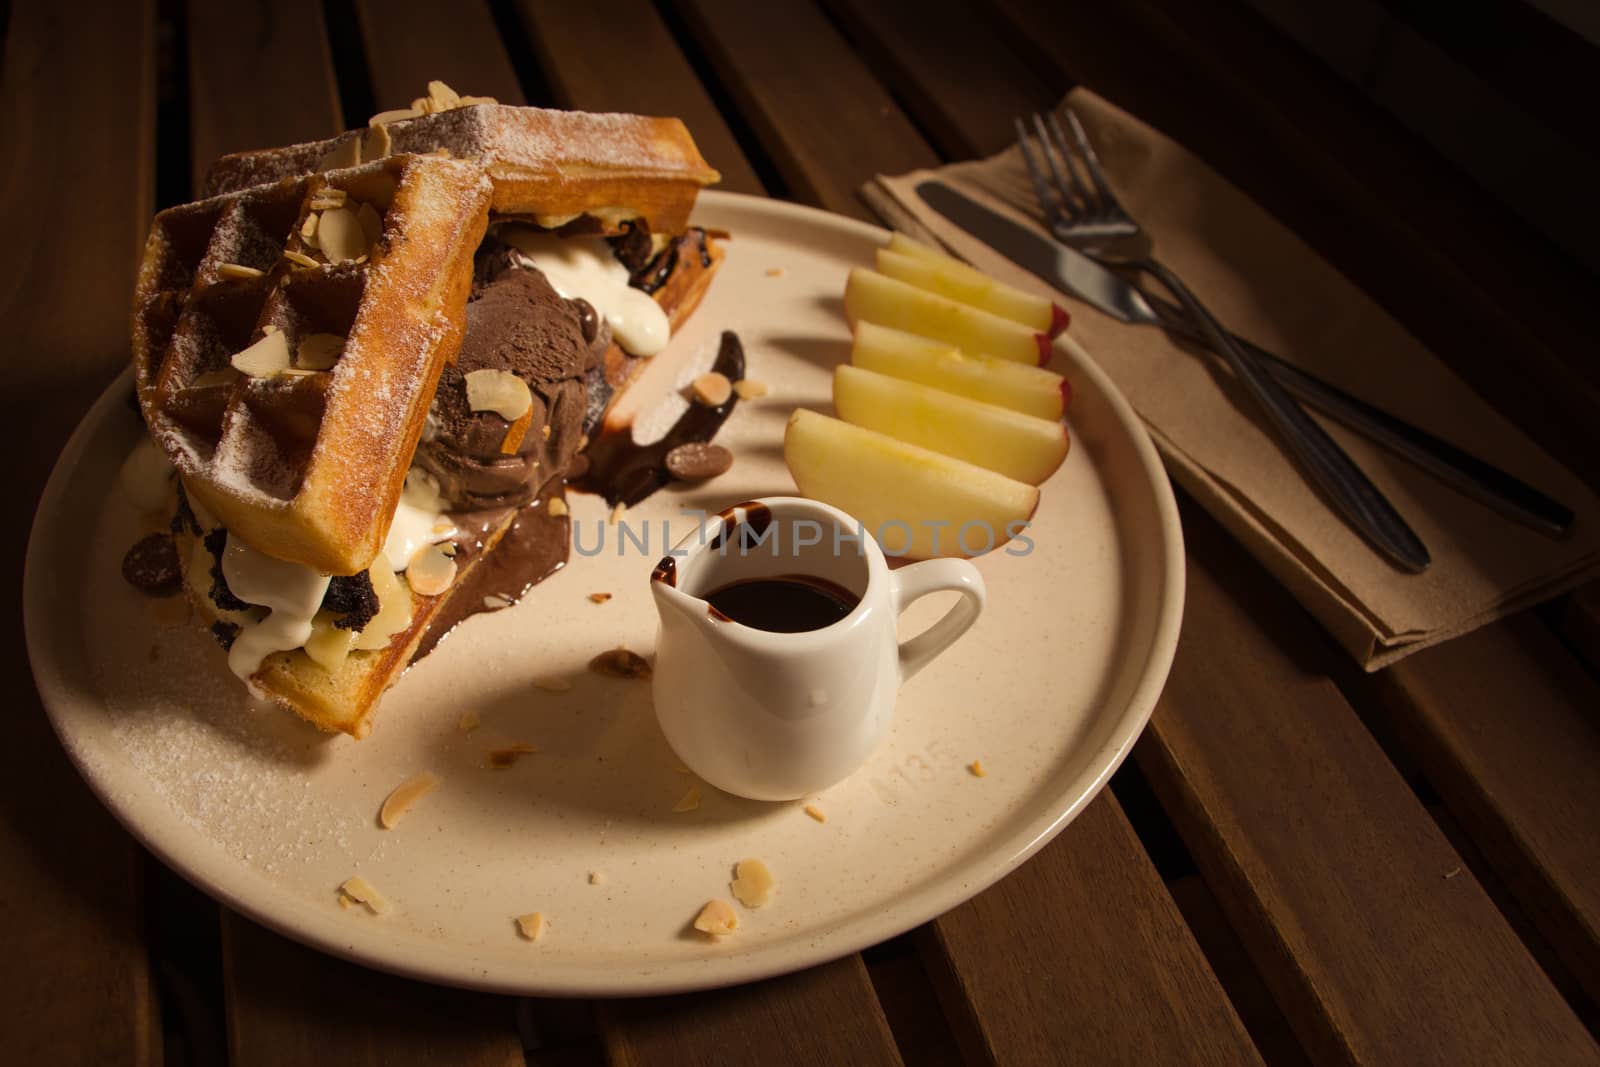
[651,498,984,800]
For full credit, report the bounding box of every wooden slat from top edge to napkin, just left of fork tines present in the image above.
[826,0,1061,160]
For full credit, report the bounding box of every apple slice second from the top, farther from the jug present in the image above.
[845,267,1050,366]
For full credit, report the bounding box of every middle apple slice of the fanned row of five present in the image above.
[850,322,1072,419]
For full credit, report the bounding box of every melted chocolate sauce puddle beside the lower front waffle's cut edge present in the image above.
[411,494,571,662]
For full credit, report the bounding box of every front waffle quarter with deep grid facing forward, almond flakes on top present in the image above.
[133,155,491,574]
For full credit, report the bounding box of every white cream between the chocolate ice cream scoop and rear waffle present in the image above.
[499,226,672,355]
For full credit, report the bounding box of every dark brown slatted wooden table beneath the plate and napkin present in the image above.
[0,0,1600,1067]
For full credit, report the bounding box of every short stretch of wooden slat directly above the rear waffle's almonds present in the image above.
[355,0,528,110]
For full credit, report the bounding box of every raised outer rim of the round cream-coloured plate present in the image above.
[22,190,1186,998]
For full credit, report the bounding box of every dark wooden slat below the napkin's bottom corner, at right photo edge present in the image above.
[1376,614,1600,1000]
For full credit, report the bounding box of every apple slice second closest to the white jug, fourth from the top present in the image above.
[834,365,1069,485]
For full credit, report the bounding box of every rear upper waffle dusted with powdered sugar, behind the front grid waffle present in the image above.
[206,104,718,234]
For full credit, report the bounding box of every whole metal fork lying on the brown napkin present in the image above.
[1016,109,1430,574]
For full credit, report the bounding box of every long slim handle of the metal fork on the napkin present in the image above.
[1133,258,1432,574]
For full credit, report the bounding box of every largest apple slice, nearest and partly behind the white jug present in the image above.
[784,408,1038,560]
